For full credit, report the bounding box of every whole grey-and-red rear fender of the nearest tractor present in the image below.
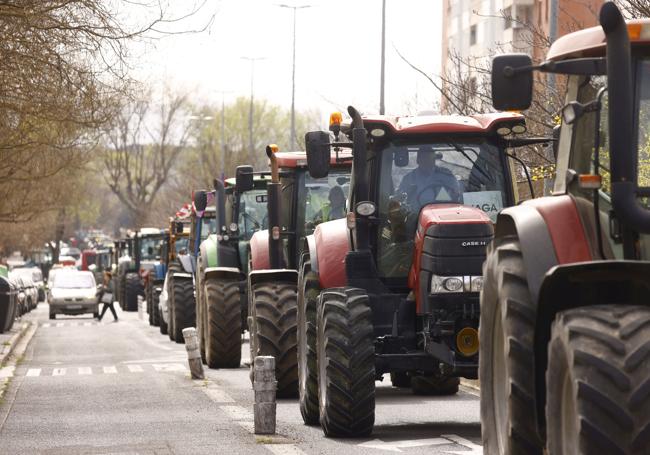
[494,195,593,302]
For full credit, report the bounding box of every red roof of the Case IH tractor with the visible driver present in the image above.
[363,112,524,136]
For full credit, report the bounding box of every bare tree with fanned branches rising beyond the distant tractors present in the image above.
[103,94,190,227]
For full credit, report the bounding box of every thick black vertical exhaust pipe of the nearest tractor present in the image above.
[600,2,650,239]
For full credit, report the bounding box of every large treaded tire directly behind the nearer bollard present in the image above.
[251,283,298,398]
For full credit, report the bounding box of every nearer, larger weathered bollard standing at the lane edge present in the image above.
[253,356,278,434]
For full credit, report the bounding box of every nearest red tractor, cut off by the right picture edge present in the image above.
[479,2,650,455]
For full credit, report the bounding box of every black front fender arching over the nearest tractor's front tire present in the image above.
[534,260,650,434]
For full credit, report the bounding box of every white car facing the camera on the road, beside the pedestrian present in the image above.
[49,270,99,319]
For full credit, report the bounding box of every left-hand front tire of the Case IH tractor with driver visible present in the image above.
[317,288,376,438]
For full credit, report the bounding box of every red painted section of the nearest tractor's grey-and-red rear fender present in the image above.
[526,195,593,264]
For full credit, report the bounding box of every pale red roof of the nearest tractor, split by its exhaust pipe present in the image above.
[546,19,650,61]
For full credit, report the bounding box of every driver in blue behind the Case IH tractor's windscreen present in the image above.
[397,145,461,211]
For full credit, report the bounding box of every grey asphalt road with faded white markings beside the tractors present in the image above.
[0,303,482,455]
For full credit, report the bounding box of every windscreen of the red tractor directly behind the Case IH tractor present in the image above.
[304,170,350,235]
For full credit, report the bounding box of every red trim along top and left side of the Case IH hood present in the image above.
[408,204,492,313]
